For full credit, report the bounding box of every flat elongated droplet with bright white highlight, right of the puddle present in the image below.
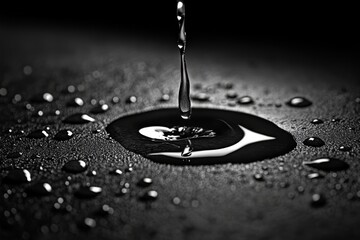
[303,158,349,172]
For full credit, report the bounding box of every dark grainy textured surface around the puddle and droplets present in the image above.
[0,27,360,239]
